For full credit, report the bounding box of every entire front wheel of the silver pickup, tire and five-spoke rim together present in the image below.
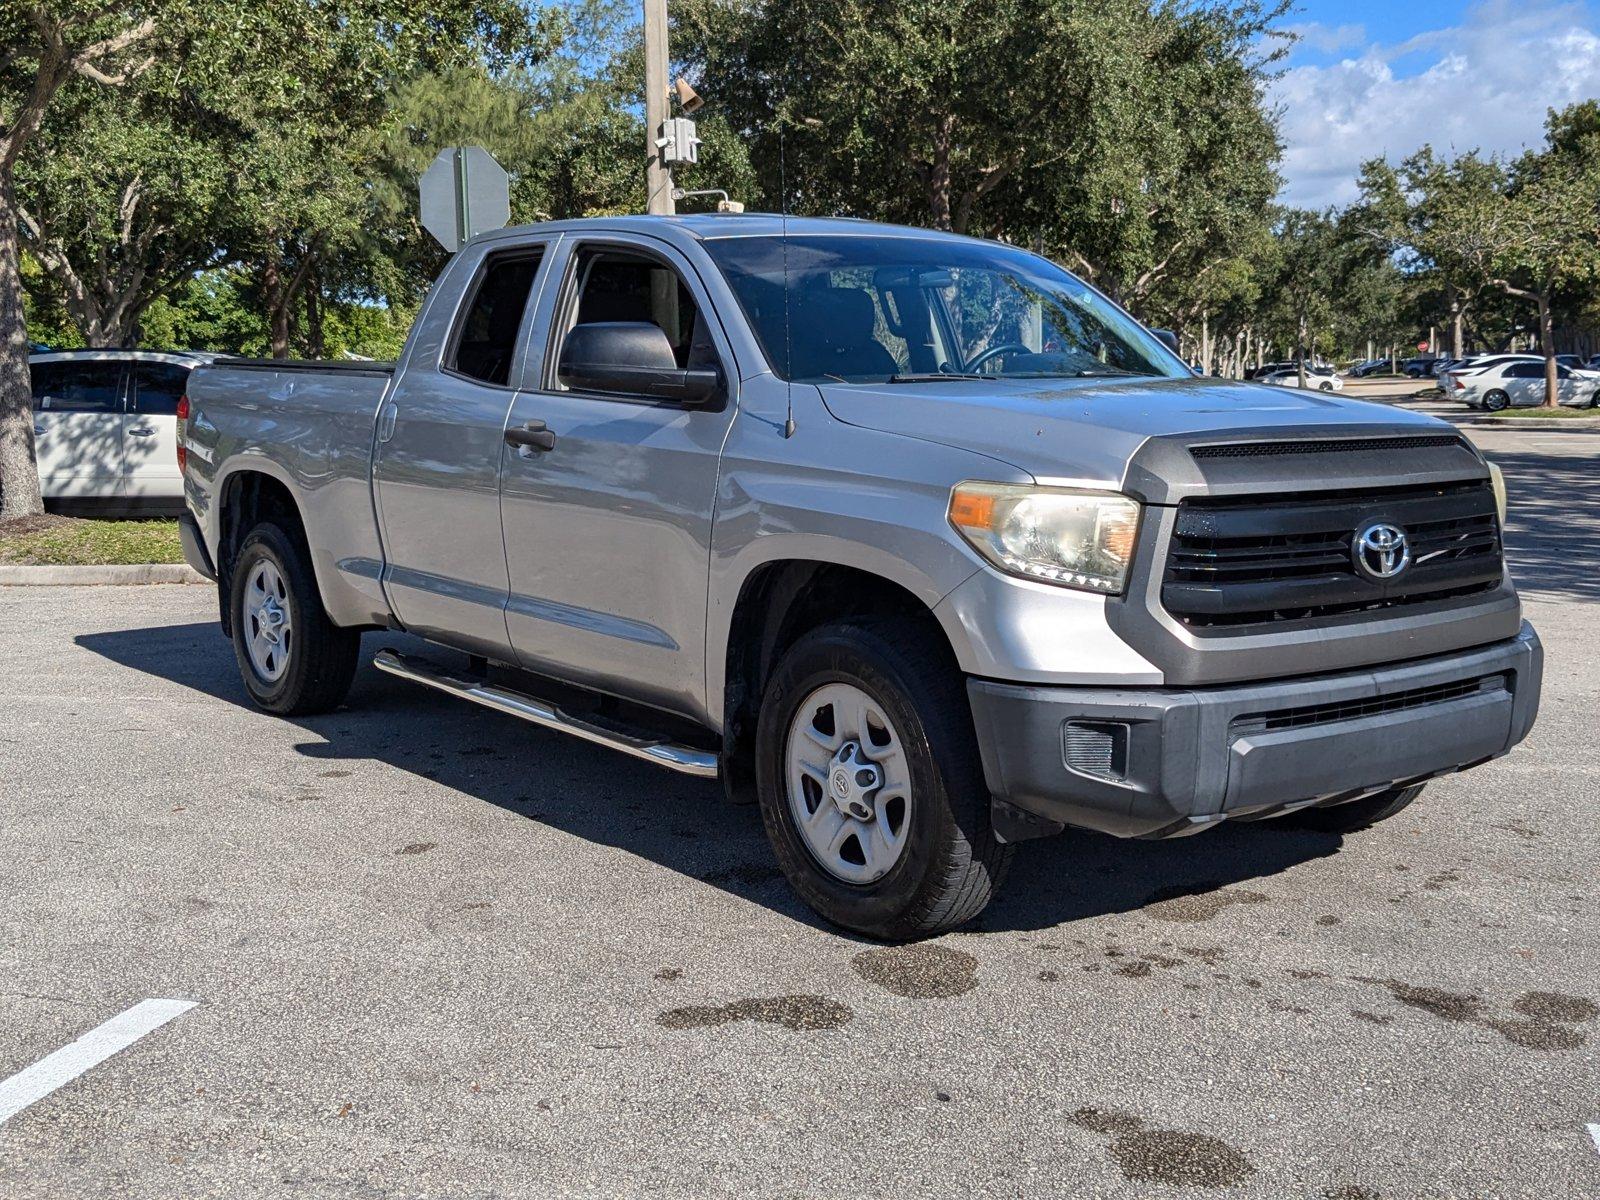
[755,621,1011,941]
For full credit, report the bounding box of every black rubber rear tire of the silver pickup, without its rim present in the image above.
[229,522,362,717]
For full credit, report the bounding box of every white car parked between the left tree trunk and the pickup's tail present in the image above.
[27,350,211,512]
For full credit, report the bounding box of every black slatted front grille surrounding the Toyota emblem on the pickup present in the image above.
[1162,482,1502,634]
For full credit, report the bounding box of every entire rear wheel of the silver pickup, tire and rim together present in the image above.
[230,522,362,717]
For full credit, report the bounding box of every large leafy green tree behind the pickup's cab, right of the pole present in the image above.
[674,0,1285,304]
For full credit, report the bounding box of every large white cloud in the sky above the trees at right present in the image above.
[1272,0,1600,208]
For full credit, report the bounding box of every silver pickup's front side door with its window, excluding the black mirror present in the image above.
[501,234,738,717]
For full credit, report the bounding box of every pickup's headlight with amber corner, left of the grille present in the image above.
[950,482,1139,595]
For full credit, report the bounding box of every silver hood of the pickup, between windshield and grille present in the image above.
[821,378,1450,486]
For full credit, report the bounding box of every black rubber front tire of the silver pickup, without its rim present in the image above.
[755,619,1013,941]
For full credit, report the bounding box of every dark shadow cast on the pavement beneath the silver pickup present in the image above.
[77,624,1341,936]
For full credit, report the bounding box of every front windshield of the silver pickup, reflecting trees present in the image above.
[704,235,1190,384]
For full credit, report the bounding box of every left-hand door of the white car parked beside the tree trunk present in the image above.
[29,358,125,499]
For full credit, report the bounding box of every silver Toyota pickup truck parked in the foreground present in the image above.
[179,214,1542,939]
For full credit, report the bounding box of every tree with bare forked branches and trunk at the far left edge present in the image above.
[0,0,158,518]
